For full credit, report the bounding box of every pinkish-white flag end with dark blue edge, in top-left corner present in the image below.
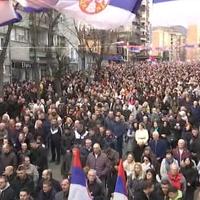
[0,0,21,26]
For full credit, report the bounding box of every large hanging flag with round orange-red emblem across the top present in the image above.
[17,0,142,29]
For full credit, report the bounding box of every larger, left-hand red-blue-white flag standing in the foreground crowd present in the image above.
[68,148,91,200]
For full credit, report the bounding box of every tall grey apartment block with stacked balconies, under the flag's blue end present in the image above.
[114,0,151,61]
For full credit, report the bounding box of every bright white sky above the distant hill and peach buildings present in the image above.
[150,0,200,27]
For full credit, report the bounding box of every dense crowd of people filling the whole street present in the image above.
[0,62,200,200]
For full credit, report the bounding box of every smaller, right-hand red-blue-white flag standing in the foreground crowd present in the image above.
[113,160,128,200]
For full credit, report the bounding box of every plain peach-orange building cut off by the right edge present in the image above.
[186,25,200,60]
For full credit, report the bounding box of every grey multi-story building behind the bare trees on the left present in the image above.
[0,12,78,82]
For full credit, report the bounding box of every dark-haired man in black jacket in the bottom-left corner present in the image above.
[0,176,16,200]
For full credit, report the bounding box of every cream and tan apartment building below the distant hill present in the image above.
[151,26,186,61]
